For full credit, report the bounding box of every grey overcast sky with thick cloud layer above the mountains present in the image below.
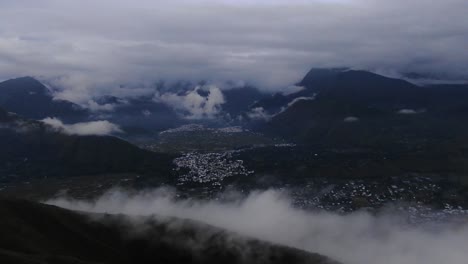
[0,0,468,100]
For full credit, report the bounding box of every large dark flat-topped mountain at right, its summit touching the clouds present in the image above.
[264,70,468,148]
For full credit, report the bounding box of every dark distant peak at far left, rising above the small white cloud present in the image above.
[0,77,87,120]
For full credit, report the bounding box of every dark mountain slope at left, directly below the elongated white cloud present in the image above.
[0,109,171,180]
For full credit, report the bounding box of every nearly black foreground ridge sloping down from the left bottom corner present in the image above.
[0,199,335,264]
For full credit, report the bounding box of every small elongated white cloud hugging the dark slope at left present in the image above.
[41,117,122,136]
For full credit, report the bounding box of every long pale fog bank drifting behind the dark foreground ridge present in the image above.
[47,189,468,264]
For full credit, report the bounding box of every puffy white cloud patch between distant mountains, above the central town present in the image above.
[154,85,225,119]
